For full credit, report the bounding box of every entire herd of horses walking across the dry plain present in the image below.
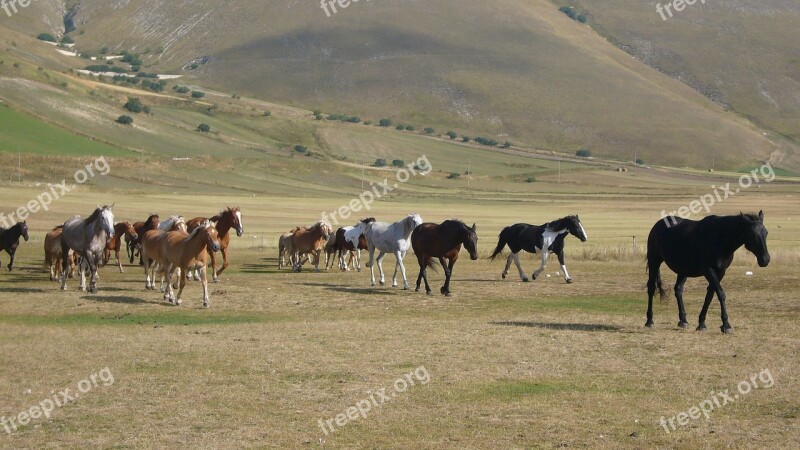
[0,205,770,333]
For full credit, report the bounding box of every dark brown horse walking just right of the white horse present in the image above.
[411,220,478,297]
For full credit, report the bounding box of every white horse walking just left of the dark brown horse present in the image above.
[364,214,422,290]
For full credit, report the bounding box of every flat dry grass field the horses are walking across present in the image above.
[0,181,800,448]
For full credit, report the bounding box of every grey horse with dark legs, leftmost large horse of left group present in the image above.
[61,204,114,294]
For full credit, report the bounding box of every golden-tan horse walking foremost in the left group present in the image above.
[161,220,222,308]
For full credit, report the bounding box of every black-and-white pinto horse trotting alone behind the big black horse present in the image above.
[489,216,589,284]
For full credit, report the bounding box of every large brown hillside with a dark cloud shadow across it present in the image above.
[3,0,797,169]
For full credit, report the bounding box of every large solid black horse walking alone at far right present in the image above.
[645,211,770,333]
